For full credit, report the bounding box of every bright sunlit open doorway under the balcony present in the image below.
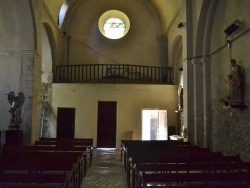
[142,109,168,140]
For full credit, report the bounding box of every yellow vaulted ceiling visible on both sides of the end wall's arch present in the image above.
[44,0,182,31]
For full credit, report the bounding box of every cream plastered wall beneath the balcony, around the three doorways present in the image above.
[52,84,177,147]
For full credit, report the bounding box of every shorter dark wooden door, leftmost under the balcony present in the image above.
[57,108,75,138]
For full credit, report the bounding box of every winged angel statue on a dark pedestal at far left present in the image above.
[8,91,25,128]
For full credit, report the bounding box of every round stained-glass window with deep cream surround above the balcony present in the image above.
[98,10,130,39]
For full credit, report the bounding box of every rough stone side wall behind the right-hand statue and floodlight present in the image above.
[211,0,250,161]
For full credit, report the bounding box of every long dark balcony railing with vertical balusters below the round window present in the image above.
[54,64,173,84]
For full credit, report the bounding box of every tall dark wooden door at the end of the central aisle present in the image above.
[97,101,117,148]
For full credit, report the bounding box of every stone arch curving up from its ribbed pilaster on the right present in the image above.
[192,0,218,147]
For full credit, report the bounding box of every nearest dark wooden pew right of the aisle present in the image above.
[133,162,250,187]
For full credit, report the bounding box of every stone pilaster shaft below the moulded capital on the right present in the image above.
[192,57,211,147]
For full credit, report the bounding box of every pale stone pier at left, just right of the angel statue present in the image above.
[20,53,41,145]
